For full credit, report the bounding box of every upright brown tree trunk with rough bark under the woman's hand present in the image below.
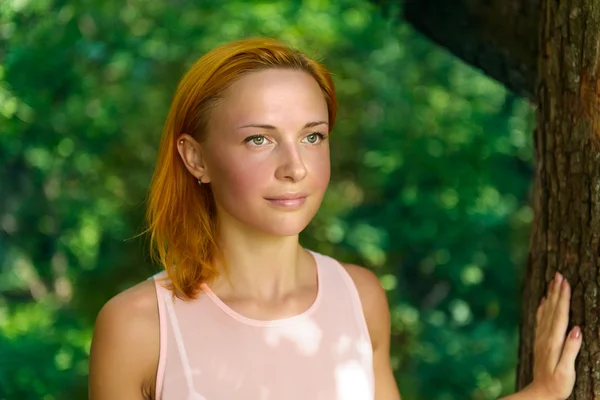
[517,0,600,400]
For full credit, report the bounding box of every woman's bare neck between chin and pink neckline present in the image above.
[212,219,308,299]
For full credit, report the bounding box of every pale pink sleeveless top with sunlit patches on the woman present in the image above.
[154,251,375,400]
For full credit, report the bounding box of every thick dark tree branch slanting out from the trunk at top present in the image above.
[398,0,541,99]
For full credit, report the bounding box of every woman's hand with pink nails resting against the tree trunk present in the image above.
[524,272,581,400]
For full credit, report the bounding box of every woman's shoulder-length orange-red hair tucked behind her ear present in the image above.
[146,38,337,299]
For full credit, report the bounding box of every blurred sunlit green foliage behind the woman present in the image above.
[0,0,534,400]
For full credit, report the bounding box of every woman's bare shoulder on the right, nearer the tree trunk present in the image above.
[342,263,390,347]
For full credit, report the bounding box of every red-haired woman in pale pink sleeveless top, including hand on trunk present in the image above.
[90,39,581,400]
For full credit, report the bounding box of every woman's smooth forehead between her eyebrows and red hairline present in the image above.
[211,69,328,126]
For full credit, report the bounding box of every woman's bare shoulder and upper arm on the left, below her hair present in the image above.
[89,280,160,400]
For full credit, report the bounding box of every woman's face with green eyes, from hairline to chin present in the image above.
[201,69,330,236]
